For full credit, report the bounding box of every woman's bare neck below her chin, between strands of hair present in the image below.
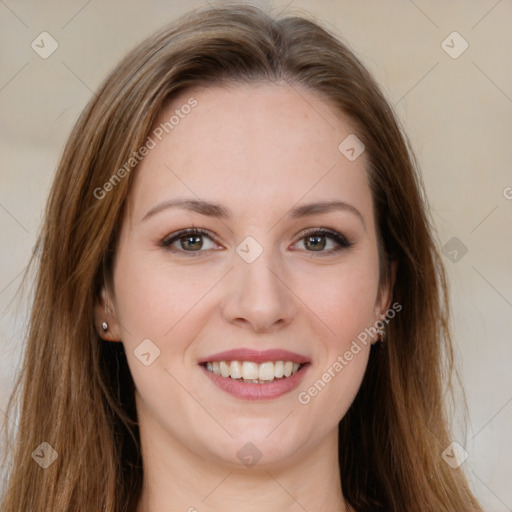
[137,418,351,512]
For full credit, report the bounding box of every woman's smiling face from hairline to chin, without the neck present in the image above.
[97,84,389,466]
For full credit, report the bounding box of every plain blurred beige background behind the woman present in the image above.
[0,0,512,512]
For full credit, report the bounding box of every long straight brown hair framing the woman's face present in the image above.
[1,5,482,512]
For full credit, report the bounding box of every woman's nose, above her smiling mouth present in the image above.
[223,245,298,333]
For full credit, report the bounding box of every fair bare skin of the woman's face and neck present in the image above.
[96,83,392,512]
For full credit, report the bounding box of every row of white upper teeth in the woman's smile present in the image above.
[206,361,301,383]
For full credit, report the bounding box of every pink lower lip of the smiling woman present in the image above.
[200,364,311,400]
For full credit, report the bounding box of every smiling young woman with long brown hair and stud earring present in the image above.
[2,5,482,512]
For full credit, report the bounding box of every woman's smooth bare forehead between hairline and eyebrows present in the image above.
[126,83,371,220]
